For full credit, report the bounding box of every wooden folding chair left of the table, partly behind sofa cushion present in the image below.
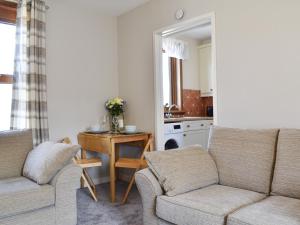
[60,138,102,202]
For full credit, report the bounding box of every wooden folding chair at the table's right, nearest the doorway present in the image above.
[115,135,153,204]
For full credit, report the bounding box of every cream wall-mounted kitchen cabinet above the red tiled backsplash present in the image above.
[198,44,214,96]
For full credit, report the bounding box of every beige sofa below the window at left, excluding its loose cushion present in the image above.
[0,130,82,225]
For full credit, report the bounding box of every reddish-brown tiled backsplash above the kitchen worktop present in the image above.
[182,89,213,116]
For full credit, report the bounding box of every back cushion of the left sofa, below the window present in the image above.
[0,130,33,179]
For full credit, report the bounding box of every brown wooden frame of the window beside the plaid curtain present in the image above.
[0,0,17,84]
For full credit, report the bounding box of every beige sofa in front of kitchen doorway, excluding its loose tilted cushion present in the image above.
[135,128,300,225]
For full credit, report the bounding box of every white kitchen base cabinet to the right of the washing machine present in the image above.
[183,120,213,149]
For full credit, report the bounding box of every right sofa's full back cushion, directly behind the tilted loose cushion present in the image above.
[209,127,278,194]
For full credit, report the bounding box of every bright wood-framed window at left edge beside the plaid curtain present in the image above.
[0,1,16,130]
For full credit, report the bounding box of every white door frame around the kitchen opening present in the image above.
[153,12,218,150]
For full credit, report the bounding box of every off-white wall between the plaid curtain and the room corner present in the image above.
[47,0,118,180]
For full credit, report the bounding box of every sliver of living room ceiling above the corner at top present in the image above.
[71,0,150,16]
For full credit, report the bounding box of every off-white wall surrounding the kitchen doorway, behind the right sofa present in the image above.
[118,0,300,130]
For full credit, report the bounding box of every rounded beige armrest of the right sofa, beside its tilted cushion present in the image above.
[135,169,163,225]
